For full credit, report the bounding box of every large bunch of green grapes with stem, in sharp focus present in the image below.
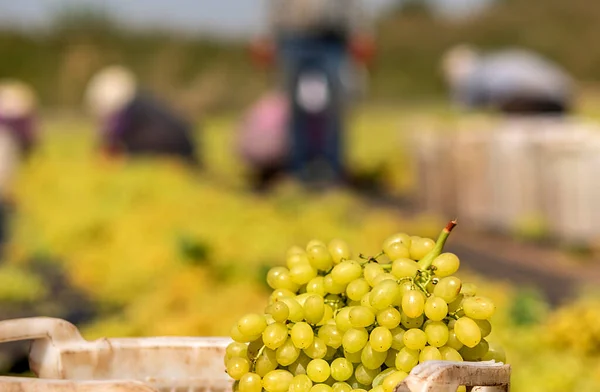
[225,222,505,392]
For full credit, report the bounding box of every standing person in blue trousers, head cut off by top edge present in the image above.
[248,0,373,185]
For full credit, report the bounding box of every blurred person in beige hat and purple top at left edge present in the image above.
[0,80,37,251]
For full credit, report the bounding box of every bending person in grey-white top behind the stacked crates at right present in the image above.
[442,45,573,114]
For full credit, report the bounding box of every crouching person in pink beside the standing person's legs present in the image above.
[236,91,289,191]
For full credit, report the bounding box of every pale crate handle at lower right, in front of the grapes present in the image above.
[394,361,510,392]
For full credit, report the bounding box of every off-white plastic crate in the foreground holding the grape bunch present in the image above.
[0,317,510,392]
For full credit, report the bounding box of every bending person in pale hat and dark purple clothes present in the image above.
[85,66,199,165]
